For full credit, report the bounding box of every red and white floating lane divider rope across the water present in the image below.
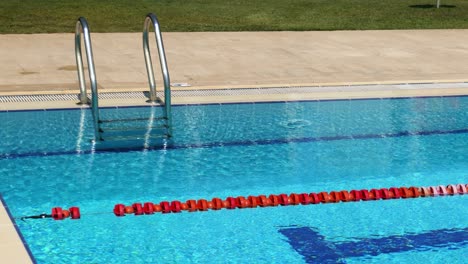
[20,184,468,220]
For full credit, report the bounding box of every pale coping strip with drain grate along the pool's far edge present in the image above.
[0,80,468,111]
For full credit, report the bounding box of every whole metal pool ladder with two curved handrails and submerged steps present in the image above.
[75,13,172,141]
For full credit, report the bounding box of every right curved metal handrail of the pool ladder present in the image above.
[143,13,172,136]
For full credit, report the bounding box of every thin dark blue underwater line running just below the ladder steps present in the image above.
[0,128,468,160]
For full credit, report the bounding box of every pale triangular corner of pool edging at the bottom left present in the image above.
[0,194,36,263]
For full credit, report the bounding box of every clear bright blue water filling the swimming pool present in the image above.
[0,97,468,263]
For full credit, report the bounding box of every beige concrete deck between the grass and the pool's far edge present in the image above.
[0,29,468,109]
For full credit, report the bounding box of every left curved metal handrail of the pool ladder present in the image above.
[75,17,100,140]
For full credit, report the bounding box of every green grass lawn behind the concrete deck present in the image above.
[0,0,468,33]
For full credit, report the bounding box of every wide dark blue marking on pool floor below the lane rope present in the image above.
[278,227,468,263]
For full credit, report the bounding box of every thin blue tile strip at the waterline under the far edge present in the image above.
[0,95,468,113]
